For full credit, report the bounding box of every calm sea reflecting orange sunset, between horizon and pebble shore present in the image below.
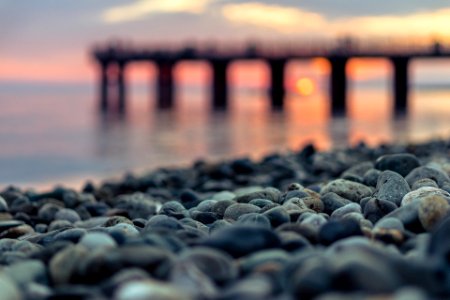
[0,59,450,189]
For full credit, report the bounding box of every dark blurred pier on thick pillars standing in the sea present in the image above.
[92,43,450,114]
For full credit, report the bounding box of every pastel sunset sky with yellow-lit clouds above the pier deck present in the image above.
[0,0,450,83]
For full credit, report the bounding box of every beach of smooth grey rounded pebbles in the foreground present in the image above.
[0,140,450,300]
